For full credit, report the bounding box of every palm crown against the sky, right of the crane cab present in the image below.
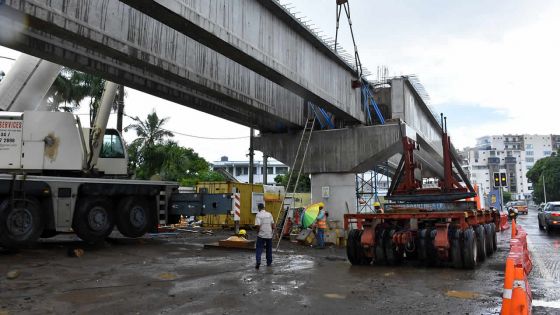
[124,111,174,147]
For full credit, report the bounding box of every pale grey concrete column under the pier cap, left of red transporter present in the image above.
[311,173,356,223]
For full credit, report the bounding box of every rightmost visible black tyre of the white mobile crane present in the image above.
[116,196,154,237]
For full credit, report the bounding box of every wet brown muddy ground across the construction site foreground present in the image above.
[0,215,556,315]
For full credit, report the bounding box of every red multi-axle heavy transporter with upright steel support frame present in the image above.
[344,117,500,269]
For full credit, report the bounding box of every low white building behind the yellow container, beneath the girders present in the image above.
[212,156,288,185]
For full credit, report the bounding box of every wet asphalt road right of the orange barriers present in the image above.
[517,207,560,314]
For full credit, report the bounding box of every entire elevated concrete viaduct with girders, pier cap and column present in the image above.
[0,0,456,222]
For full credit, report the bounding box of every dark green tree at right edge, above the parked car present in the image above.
[527,154,560,203]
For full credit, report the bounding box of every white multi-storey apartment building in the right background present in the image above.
[461,135,560,199]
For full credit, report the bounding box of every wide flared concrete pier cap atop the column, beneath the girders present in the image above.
[253,123,443,177]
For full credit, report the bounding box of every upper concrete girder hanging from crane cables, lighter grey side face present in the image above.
[120,0,365,124]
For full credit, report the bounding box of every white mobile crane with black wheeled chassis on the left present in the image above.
[0,55,231,247]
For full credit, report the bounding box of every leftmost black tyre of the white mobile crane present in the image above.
[0,198,44,248]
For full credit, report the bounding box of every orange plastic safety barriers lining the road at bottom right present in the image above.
[501,220,533,315]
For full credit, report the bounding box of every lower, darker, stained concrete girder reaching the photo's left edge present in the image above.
[0,0,320,132]
